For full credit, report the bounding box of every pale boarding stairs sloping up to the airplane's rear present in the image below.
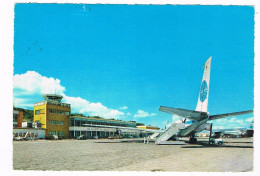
[155,123,185,144]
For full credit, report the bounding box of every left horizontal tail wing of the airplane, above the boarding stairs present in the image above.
[159,106,206,121]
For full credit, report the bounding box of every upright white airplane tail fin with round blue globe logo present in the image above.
[196,56,211,112]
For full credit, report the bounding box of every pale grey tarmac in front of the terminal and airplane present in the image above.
[13,138,254,172]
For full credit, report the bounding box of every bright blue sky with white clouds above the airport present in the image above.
[14,4,254,128]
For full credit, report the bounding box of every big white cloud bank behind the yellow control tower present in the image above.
[14,71,126,119]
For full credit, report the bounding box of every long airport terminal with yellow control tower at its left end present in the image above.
[23,94,153,139]
